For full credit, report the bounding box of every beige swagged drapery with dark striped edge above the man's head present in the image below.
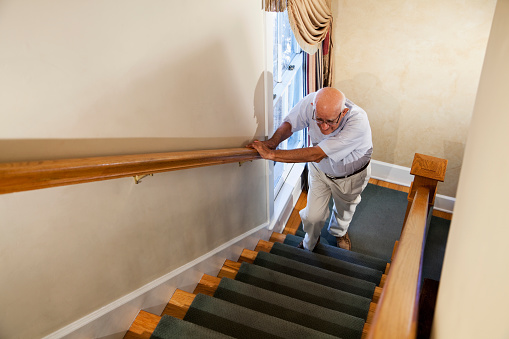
[265,0,334,89]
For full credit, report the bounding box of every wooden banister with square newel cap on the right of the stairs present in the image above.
[368,154,447,339]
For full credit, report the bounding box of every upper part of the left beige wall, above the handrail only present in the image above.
[0,0,264,161]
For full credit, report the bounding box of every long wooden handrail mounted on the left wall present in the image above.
[0,148,261,194]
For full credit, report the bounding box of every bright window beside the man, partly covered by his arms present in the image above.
[271,11,306,198]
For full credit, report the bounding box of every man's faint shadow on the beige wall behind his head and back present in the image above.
[336,73,401,164]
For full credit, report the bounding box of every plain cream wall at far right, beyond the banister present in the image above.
[432,0,509,339]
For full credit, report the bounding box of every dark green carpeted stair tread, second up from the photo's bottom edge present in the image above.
[184,294,337,339]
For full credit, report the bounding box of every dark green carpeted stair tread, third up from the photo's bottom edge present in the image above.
[214,278,364,339]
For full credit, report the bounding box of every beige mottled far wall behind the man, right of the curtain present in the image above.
[333,0,496,197]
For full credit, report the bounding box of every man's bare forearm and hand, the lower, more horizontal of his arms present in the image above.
[252,141,327,163]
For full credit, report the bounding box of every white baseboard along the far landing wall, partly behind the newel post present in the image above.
[371,160,456,213]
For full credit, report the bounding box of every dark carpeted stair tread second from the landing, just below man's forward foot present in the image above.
[270,243,383,285]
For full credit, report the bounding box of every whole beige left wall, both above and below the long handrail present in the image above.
[0,0,267,338]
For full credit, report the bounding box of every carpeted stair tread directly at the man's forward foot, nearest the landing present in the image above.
[284,234,387,272]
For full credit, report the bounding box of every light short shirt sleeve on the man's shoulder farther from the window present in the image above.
[318,115,370,162]
